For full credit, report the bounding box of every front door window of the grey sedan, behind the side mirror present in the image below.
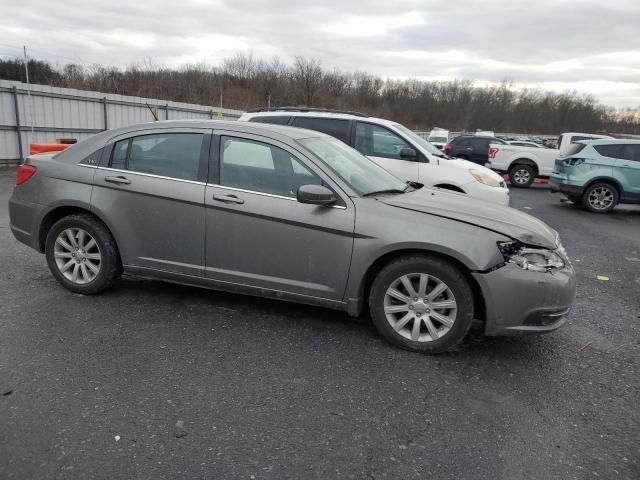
[220,137,322,198]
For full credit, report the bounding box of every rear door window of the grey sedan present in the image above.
[110,133,204,180]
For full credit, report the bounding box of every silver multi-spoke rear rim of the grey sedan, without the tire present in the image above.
[54,228,102,285]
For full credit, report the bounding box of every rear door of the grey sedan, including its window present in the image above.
[91,129,211,277]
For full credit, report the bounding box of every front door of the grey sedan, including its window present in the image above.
[205,132,355,301]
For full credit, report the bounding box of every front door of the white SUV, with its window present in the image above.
[354,121,420,182]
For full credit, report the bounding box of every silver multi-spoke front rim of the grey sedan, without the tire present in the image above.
[384,273,458,342]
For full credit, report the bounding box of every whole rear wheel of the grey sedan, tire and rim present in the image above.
[45,214,122,295]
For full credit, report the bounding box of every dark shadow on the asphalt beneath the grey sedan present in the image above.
[96,277,554,361]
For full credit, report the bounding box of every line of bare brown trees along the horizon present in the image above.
[0,53,640,134]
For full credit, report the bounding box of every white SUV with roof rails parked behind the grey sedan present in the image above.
[239,108,509,205]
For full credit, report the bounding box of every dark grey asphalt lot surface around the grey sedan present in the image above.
[0,169,640,480]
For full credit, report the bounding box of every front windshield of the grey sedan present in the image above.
[298,137,407,195]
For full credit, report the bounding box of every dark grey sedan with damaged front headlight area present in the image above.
[9,121,575,353]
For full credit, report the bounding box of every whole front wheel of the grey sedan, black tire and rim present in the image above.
[369,255,473,354]
